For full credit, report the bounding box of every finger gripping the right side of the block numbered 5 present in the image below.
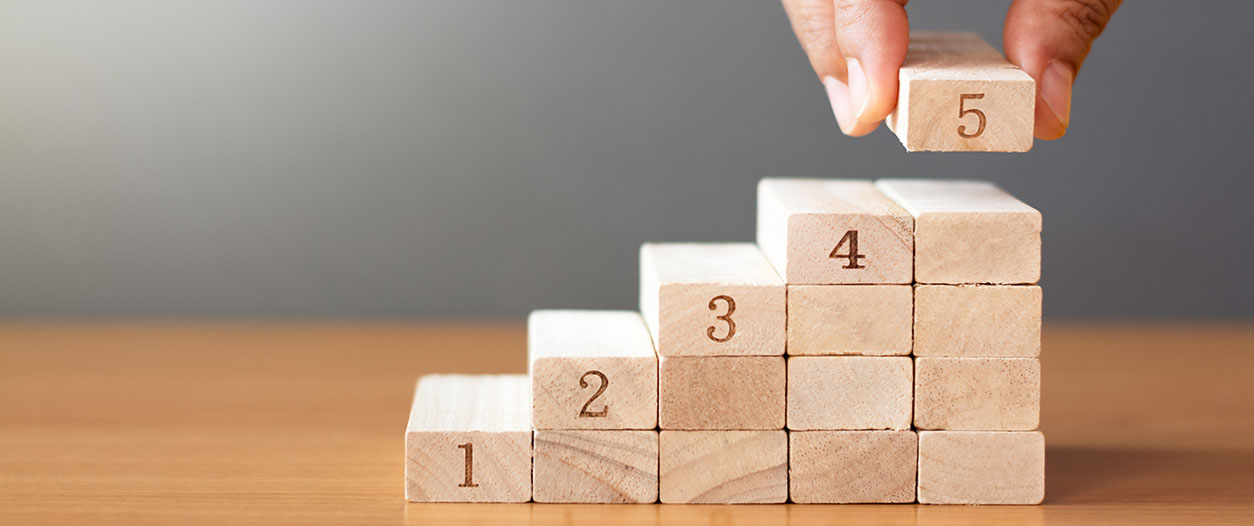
[1002,0,1122,139]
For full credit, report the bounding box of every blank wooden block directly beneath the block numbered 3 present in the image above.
[658,357,788,429]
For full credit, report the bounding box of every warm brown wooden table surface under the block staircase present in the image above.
[0,323,1254,526]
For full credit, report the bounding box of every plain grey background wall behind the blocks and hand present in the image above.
[0,0,1254,318]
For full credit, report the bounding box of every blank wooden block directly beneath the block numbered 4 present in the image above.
[788,285,914,357]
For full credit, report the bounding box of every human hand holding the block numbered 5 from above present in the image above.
[782,0,1122,139]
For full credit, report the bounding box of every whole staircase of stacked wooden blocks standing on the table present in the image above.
[405,178,1045,505]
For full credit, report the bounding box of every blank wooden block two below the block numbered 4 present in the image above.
[788,357,914,429]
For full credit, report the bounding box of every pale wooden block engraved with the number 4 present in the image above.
[757,178,914,285]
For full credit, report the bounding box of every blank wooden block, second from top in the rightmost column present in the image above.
[912,285,1041,358]
